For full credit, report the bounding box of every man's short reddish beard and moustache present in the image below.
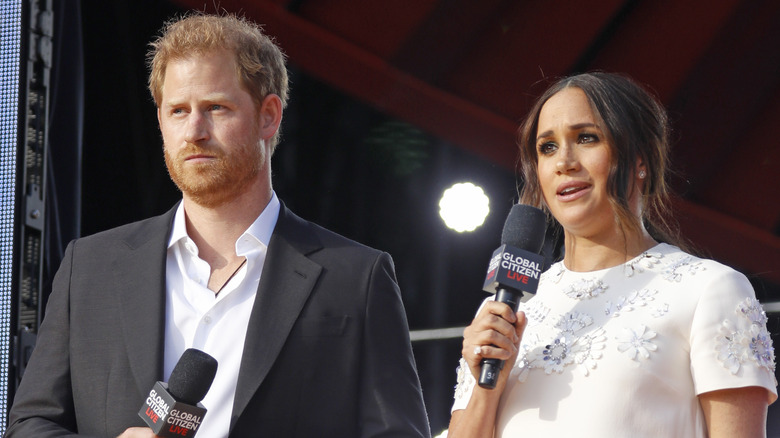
[163,140,264,208]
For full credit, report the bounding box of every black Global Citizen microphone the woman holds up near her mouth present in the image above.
[479,204,546,389]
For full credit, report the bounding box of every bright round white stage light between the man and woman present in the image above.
[439,183,490,233]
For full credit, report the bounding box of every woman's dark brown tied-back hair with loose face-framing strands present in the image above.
[518,72,681,245]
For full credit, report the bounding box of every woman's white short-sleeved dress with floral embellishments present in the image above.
[453,244,777,438]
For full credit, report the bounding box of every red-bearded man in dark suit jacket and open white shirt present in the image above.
[7,15,430,438]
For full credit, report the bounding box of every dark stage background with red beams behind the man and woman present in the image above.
[39,0,780,433]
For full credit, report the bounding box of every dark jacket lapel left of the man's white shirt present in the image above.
[114,208,175,394]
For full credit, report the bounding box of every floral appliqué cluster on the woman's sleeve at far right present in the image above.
[715,298,775,374]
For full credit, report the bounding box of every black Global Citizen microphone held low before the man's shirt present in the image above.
[138,348,217,438]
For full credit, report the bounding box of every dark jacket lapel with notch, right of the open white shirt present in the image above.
[231,205,322,429]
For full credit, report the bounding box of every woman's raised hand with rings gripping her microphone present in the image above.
[461,301,527,392]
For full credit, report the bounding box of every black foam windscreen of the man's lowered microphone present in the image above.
[168,348,217,405]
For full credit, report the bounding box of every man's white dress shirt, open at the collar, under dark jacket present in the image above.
[164,193,280,437]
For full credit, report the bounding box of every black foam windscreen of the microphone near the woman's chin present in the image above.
[501,204,547,254]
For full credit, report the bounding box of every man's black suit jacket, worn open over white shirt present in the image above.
[6,205,430,438]
